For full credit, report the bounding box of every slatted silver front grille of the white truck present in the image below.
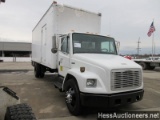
[111,69,142,90]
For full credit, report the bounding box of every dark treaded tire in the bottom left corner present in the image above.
[4,103,37,120]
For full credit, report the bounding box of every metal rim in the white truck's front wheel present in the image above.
[65,87,76,107]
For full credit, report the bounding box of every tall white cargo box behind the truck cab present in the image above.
[32,3,101,69]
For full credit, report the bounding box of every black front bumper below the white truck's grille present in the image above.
[80,90,144,108]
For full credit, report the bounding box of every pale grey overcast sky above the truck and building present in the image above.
[0,0,160,53]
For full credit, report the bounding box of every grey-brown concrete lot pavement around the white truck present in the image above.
[0,62,160,120]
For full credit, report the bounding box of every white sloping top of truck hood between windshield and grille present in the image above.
[73,54,141,70]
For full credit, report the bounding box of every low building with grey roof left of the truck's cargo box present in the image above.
[0,41,31,62]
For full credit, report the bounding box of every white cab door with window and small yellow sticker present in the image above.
[58,36,71,77]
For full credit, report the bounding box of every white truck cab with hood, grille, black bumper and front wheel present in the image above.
[52,33,144,115]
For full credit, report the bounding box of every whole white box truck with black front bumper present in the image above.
[32,2,144,115]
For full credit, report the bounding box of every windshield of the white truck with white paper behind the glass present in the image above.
[72,33,117,54]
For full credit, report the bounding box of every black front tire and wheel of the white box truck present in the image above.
[64,79,81,116]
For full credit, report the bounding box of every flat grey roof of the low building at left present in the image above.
[0,41,31,51]
